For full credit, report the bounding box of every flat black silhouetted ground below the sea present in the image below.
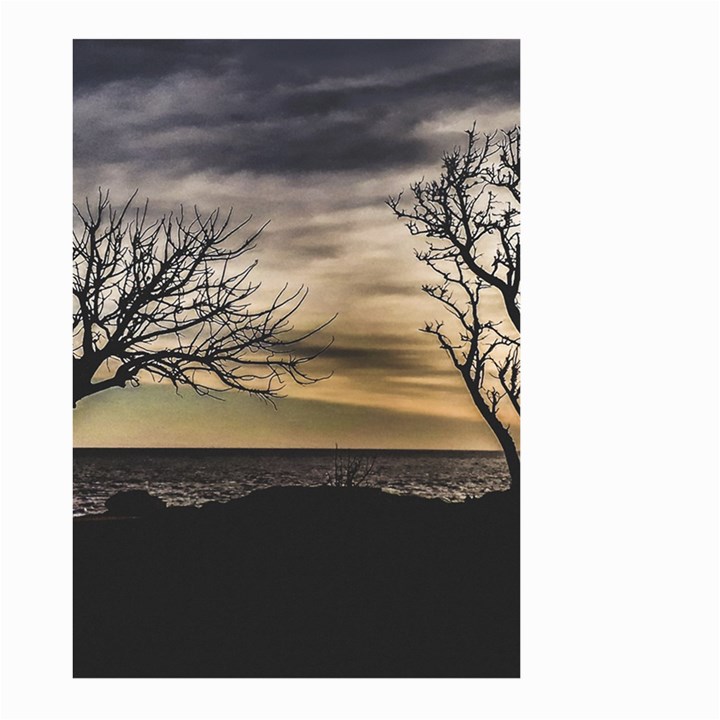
[74,487,520,677]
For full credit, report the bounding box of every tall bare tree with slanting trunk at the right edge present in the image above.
[387,126,520,489]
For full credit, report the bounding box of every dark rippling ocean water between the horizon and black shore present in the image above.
[73,448,510,515]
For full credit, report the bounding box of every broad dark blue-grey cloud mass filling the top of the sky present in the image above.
[75,41,519,175]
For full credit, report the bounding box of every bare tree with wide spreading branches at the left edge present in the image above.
[73,190,328,406]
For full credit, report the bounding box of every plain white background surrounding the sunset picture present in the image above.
[2,0,718,720]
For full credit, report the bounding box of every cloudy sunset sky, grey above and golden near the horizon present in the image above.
[73,40,520,450]
